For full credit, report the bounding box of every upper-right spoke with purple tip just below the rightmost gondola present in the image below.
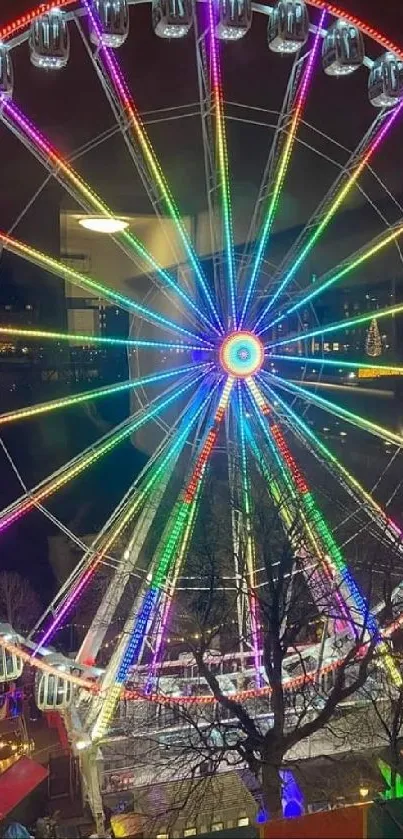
[256,103,403,326]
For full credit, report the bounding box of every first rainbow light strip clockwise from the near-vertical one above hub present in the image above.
[239,11,326,326]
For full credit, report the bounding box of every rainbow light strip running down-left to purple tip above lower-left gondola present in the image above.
[34,376,214,655]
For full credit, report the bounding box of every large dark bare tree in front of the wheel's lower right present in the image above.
[147,460,386,818]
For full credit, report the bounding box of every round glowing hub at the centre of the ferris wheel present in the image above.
[220,330,264,379]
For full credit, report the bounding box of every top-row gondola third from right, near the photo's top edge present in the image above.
[267,0,309,53]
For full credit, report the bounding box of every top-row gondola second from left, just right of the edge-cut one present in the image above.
[29,9,70,70]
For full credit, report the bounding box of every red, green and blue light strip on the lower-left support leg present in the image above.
[91,377,234,740]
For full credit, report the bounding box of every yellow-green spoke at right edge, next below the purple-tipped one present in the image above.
[258,221,403,335]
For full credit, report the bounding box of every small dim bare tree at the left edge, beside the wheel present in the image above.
[0,571,41,633]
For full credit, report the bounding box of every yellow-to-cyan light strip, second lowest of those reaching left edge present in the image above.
[0,365,213,426]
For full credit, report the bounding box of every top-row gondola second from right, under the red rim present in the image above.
[322,20,365,76]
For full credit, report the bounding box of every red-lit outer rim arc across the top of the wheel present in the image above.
[0,0,403,60]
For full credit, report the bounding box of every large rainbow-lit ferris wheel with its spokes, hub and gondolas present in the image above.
[0,0,403,756]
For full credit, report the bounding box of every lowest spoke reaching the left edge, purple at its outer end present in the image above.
[0,367,205,532]
